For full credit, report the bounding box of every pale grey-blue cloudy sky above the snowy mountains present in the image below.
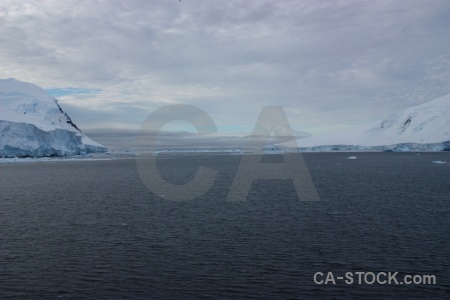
[0,0,450,139]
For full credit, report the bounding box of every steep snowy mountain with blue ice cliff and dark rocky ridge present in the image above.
[0,78,106,157]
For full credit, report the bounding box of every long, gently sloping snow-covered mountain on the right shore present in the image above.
[298,94,450,151]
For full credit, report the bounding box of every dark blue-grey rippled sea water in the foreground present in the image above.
[0,153,450,299]
